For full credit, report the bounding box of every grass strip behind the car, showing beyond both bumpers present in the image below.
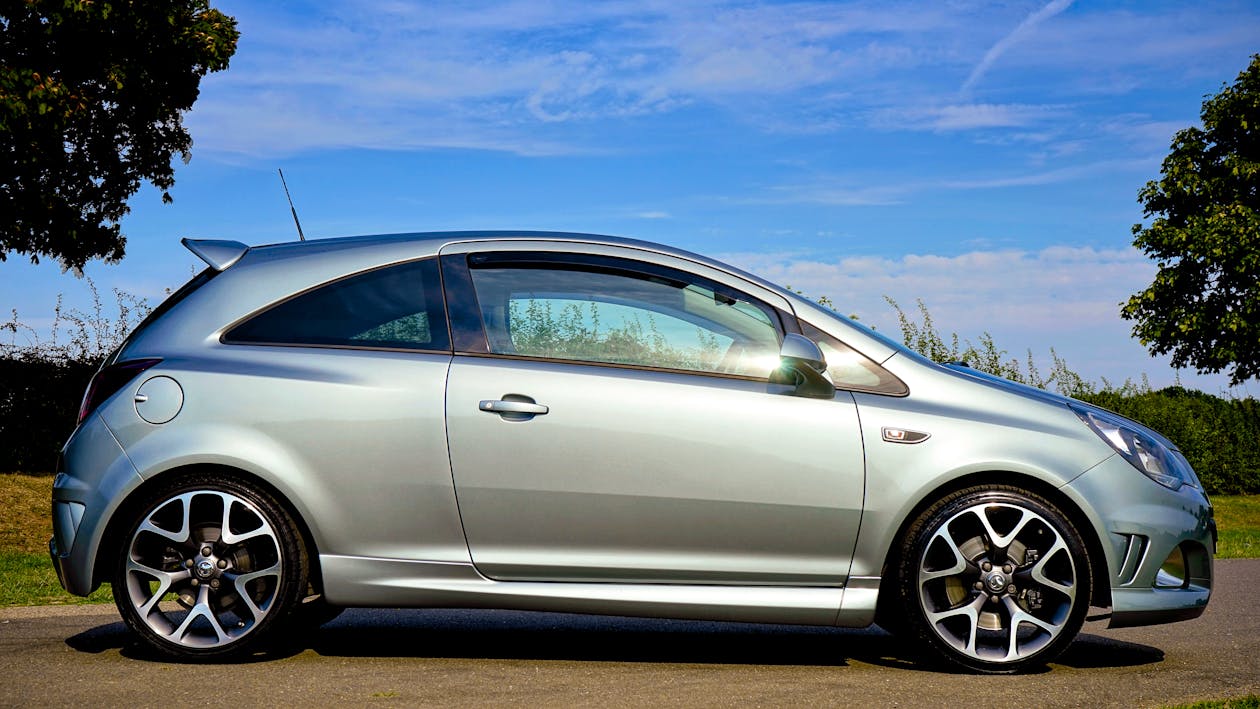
[0,474,1260,606]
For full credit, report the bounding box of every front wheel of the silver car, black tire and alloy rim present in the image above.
[896,486,1092,674]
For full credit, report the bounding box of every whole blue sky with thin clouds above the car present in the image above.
[0,0,1260,395]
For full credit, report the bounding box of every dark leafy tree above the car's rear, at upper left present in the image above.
[0,0,239,269]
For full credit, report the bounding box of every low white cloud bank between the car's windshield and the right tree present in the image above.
[721,246,1221,390]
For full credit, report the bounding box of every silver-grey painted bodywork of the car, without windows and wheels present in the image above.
[46,233,1212,625]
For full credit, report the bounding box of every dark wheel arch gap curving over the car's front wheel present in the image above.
[877,470,1111,609]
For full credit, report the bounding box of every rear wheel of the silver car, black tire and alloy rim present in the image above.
[113,474,309,660]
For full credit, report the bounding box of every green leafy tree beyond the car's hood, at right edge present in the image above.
[1120,54,1260,385]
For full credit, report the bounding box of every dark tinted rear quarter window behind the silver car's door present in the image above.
[224,258,450,350]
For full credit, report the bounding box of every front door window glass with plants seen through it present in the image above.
[471,263,781,378]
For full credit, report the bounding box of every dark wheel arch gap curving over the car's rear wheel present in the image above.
[92,463,324,593]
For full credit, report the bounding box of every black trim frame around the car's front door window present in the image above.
[451,251,799,383]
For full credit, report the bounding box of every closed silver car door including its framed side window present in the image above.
[442,243,863,586]
